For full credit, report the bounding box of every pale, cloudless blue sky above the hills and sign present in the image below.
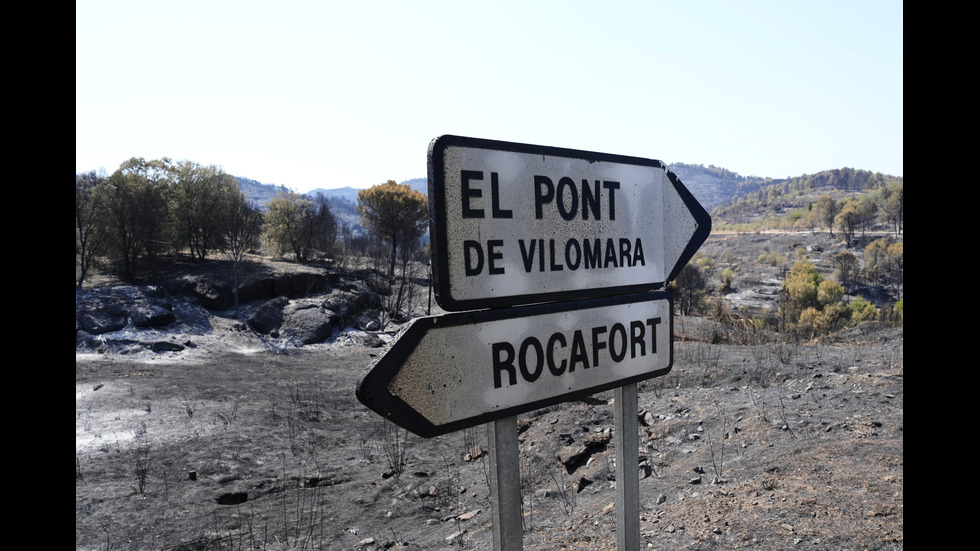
[75,0,904,192]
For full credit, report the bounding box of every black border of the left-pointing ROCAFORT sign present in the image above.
[356,290,674,438]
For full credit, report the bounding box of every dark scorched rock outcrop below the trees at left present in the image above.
[75,272,397,351]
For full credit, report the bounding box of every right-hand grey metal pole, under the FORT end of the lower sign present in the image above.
[614,383,640,551]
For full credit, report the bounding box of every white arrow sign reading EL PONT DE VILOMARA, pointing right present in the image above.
[428,136,711,311]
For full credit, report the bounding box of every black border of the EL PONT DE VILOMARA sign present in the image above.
[428,134,711,312]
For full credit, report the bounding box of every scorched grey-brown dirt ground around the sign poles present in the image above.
[75,231,904,551]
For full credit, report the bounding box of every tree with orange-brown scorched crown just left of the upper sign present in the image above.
[357,180,429,277]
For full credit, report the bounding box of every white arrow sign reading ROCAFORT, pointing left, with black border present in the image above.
[357,291,673,437]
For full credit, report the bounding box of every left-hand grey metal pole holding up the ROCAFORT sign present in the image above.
[487,412,524,551]
